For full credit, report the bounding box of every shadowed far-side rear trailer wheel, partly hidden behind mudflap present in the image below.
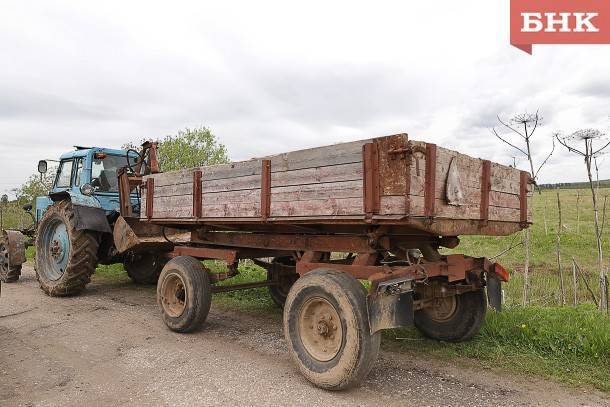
[414,290,487,342]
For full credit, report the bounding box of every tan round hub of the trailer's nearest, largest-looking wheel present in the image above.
[299,297,343,362]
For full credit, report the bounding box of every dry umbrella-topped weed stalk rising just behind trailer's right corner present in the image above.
[491,111,555,305]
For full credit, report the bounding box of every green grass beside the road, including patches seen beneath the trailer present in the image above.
[7,189,610,392]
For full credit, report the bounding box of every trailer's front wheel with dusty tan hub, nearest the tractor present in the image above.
[157,256,212,332]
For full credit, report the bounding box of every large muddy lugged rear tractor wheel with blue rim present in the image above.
[36,201,99,297]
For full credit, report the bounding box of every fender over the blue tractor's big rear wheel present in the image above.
[49,191,112,233]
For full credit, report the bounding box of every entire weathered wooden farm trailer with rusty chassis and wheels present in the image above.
[114,134,532,389]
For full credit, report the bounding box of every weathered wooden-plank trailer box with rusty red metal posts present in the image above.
[140,134,532,236]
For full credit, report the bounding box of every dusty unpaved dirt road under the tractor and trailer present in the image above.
[0,267,610,406]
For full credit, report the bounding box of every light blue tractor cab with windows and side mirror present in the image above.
[35,147,139,221]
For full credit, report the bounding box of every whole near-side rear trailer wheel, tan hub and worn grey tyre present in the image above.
[284,269,381,390]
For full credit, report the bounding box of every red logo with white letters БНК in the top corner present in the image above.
[510,0,610,54]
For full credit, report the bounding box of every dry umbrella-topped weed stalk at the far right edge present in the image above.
[556,129,610,311]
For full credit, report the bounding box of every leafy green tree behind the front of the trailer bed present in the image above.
[123,127,229,171]
